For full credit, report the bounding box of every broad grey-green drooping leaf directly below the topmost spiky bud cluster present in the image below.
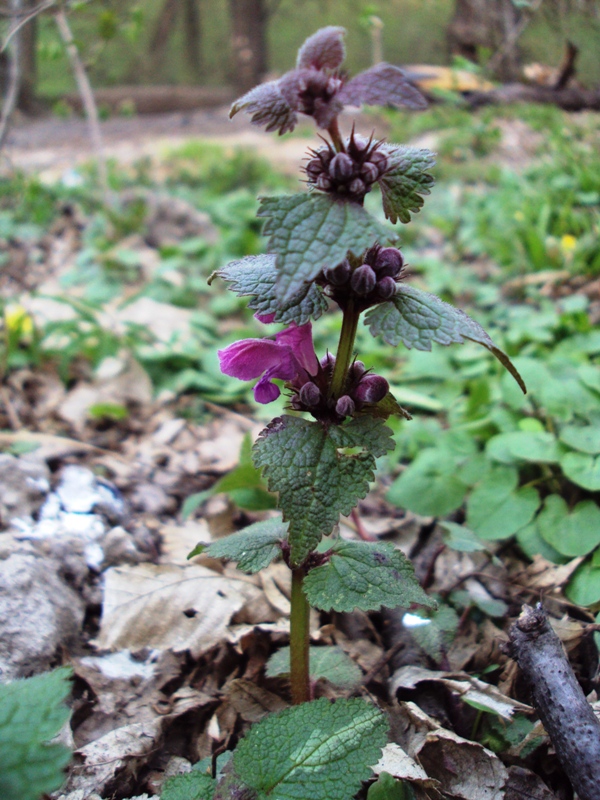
[258,194,394,304]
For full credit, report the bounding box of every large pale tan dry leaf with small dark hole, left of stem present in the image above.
[97,564,259,658]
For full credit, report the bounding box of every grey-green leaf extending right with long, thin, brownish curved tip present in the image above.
[366,284,527,392]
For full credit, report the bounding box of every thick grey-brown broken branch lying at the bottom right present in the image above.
[509,604,600,800]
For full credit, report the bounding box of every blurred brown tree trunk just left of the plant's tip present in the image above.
[229,0,269,92]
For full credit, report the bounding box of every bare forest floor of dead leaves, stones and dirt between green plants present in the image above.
[0,108,598,800]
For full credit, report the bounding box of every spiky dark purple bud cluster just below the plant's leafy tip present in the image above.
[304,132,389,202]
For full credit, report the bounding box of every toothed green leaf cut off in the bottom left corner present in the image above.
[0,668,71,800]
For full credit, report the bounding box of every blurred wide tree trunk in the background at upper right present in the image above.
[447,0,522,81]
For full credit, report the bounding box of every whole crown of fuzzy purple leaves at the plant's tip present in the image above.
[230,26,426,134]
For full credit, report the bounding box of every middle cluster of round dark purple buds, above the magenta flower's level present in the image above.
[317,245,404,310]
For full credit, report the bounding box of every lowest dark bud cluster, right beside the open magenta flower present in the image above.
[290,353,389,422]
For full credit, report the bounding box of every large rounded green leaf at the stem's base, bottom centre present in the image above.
[215,698,388,800]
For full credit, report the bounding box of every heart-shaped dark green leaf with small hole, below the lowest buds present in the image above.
[254,416,394,565]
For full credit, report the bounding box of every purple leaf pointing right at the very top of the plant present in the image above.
[339,64,427,109]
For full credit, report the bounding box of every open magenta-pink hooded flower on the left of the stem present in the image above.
[218,314,319,403]
